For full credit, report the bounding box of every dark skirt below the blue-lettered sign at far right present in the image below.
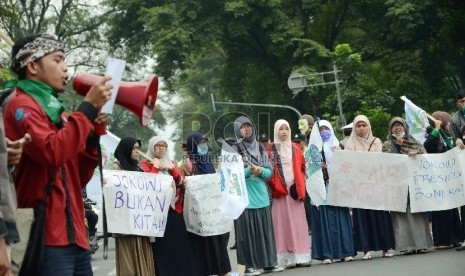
[432,208,462,246]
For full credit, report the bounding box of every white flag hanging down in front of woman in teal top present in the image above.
[220,142,249,219]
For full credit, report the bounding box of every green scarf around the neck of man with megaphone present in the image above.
[17,80,65,123]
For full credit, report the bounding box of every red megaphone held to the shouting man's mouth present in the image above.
[73,73,158,126]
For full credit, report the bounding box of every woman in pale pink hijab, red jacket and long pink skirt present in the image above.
[269,120,311,268]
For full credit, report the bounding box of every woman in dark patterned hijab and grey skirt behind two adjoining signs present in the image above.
[383,117,433,255]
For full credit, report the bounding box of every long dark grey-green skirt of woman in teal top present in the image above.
[236,206,278,269]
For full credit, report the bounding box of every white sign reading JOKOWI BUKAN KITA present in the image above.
[103,170,174,237]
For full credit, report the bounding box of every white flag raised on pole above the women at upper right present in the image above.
[400,96,429,144]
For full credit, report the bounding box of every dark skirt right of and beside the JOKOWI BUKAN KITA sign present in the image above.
[152,208,192,276]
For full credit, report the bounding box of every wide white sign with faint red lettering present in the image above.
[327,150,411,212]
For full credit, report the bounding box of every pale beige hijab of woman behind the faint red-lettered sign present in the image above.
[344,115,382,152]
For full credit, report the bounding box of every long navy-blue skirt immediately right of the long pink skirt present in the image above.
[311,205,356,260]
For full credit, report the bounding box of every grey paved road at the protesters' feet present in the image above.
[92,239,465,276]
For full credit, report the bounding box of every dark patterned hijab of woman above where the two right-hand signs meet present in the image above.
[383,117,426,154]
